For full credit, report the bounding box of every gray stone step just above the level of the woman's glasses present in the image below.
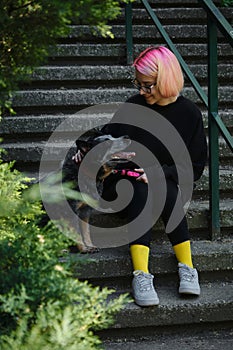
[29,64,233,87]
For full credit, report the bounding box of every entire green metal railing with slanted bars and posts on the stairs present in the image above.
[126,0,233,239]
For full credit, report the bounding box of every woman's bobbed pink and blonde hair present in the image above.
[133,46,184,98]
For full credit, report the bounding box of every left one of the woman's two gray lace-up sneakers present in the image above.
[132,270,159,306]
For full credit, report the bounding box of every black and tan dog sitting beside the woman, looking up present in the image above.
[47,130,137,253]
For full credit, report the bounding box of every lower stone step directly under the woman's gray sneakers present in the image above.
[98,281,233,340]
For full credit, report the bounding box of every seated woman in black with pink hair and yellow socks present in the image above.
[103,46,207,306]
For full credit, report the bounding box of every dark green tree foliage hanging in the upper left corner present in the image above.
[0,0,132,115]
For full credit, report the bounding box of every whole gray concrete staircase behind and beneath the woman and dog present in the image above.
[0,0,233,344]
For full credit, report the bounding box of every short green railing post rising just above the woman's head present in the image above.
[125,3,133,64]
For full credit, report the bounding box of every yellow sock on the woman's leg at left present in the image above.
[130,244,150,273]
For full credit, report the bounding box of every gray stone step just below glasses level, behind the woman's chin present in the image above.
[13,86,233,110]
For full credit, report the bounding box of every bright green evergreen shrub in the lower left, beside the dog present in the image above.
[0,161,128,350]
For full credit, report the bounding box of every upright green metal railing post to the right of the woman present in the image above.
[207,15,220,240]
